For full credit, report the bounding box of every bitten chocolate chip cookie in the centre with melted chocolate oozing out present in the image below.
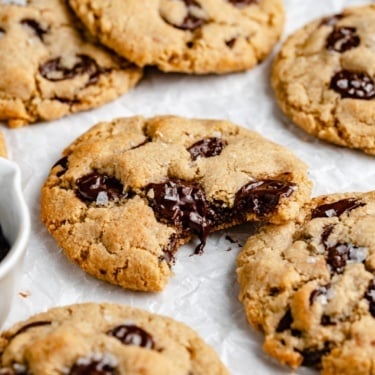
[41,116,311,291]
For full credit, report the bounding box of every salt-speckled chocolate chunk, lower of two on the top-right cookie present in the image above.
[330,70,375,100]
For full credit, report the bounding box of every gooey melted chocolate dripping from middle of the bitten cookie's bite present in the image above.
[146,179,211,254]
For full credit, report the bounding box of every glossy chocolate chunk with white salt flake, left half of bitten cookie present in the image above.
[76,172,128,205]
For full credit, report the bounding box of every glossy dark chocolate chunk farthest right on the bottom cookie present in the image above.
[107,325,155,349]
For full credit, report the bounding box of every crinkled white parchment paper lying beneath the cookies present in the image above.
[0,0,375,375]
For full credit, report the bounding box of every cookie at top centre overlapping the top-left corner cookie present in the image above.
[69,0,284,74]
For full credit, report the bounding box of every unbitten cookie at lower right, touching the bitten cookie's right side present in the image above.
[237,192,375,375]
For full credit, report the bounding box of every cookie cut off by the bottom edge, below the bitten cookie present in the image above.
[0,303,228,375]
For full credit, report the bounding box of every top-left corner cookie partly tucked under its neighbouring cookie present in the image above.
[0,0,141,127]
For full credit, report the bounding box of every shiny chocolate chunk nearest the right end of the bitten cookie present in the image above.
[234,180,295,217]
